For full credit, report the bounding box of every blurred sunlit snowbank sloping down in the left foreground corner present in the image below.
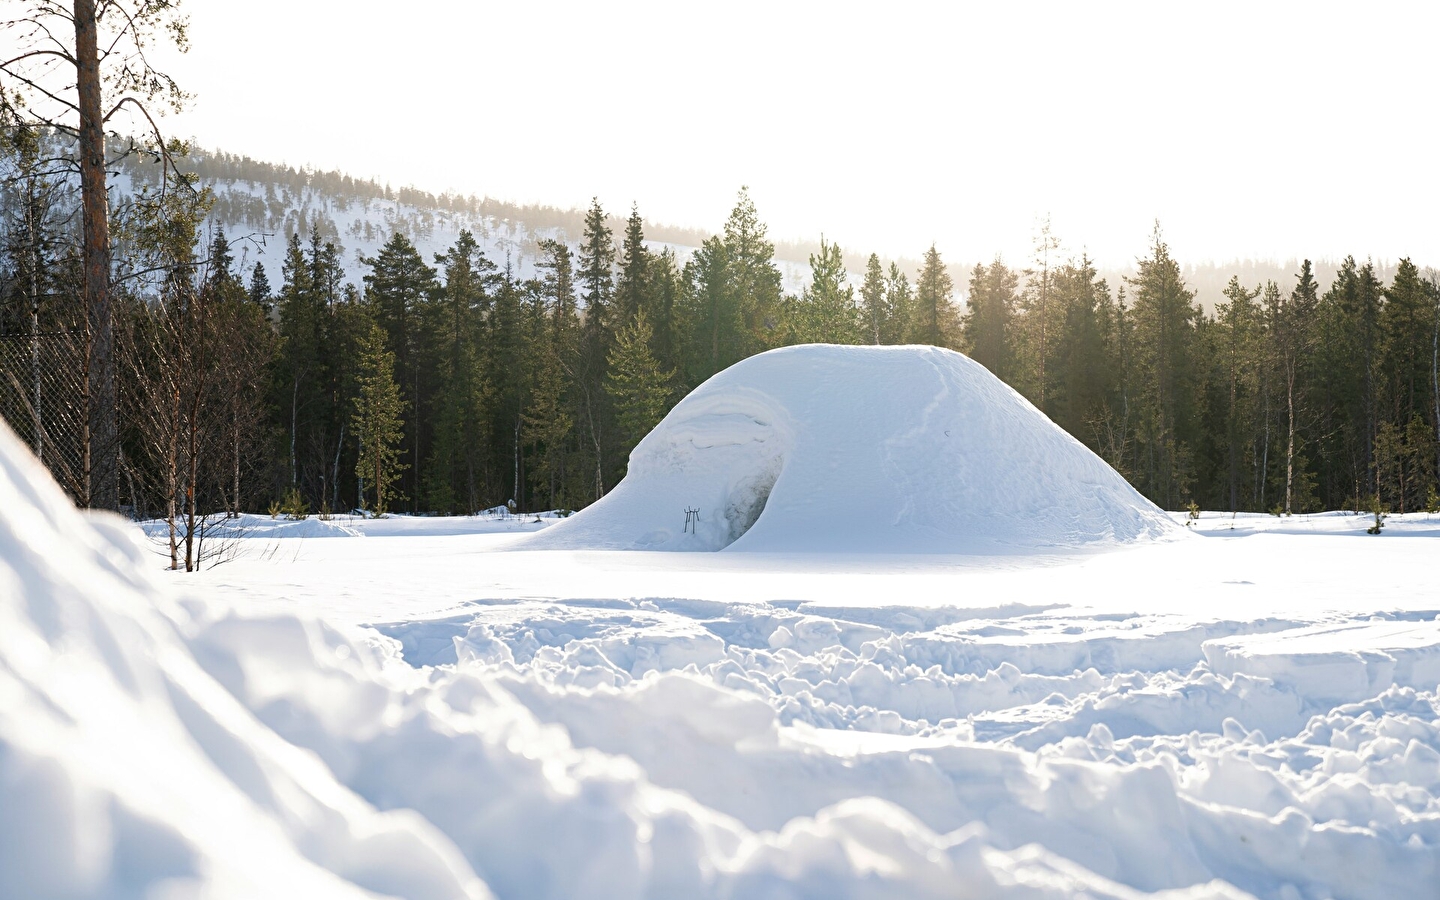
[0,422,491,899]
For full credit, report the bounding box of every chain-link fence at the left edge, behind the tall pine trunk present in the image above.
[0,331,88,500]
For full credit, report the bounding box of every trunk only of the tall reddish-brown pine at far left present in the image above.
[75,0,120,510]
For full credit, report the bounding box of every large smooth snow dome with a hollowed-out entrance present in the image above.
[526,344,1179,554]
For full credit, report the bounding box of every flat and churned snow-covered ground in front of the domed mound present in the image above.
[135,513,1440,900]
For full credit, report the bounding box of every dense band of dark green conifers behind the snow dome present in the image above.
[0,130,1440,547]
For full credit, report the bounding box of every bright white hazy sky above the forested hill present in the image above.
[151,0,1440,264]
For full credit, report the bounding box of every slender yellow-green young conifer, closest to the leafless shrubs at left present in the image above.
[350,324,405,517]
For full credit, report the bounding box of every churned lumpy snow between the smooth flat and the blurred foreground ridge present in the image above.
[368,593,1440,897]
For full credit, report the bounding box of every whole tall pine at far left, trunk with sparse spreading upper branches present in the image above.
[0,0,189,508]
